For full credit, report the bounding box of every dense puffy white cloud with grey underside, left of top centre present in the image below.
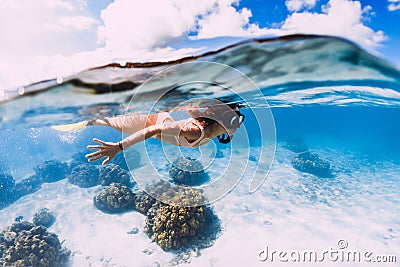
[99,0,197,54]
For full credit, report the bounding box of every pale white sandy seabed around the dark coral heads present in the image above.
[0,144,400,266]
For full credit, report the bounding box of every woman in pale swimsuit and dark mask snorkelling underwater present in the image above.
[86,104,245,164]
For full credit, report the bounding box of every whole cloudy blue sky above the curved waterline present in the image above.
[0,0,400,91]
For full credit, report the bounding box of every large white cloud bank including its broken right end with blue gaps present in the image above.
[99,0,266,55]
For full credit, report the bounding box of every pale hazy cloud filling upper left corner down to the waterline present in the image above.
[0,0,99,89]
